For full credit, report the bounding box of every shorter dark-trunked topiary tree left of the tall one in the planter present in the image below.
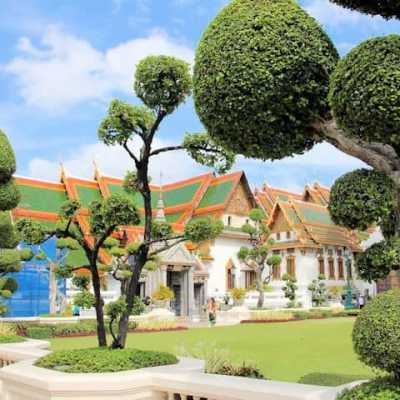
[17,194,140,346]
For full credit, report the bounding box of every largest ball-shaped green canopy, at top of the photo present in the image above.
[194,0,338,159]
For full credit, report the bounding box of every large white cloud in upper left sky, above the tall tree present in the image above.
[2,26,193,111]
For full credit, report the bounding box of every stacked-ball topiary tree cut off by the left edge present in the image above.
[0,130,30,314]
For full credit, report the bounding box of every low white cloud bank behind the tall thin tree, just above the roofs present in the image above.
[28,139,208,182]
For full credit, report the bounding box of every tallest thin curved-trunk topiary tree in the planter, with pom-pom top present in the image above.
[98,56,234,348]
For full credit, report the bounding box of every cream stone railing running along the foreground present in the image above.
[0,341,360,400]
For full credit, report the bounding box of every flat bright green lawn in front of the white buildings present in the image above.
[51,318,373,386]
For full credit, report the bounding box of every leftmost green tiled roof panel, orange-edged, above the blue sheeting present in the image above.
[18,184,68,213]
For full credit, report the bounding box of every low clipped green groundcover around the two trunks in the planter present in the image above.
[35,348,178,373]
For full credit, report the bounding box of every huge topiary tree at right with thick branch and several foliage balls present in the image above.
[194,0,400,288]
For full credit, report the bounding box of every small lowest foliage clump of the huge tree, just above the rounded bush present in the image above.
[356,239,400,282]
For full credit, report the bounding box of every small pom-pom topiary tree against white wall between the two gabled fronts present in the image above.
[238,208,282,308]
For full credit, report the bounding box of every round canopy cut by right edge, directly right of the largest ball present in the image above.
[329,35,400,148]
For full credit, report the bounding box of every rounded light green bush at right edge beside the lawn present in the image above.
[353,290,400,379]
